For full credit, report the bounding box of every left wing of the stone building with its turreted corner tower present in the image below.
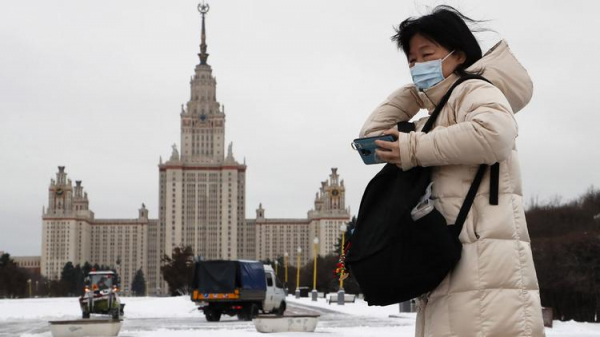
[40,166,158,287]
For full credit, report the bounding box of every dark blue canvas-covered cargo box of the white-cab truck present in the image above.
[192,260,267,301]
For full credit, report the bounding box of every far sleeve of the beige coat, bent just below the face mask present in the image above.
[359,84,422,137]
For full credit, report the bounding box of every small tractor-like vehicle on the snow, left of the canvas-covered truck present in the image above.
[79,271,125,319]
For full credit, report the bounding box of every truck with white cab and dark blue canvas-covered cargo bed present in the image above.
[191,260,286,322]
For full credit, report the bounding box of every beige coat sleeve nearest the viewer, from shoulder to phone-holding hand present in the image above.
[398,81,517,170]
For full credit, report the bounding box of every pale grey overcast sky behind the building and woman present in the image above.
[0,0,600,255]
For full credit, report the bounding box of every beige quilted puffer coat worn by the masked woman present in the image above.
[361,41,544,337]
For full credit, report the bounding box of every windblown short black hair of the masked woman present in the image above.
[392,5,483,76]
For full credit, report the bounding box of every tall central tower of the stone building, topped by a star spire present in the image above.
[155,4,251,287]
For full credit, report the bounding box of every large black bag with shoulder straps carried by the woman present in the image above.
[345,75,498,305]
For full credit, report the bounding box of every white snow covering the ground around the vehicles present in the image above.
[0,296,600,337]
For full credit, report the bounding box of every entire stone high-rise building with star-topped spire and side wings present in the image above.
[40,5,350,295]
